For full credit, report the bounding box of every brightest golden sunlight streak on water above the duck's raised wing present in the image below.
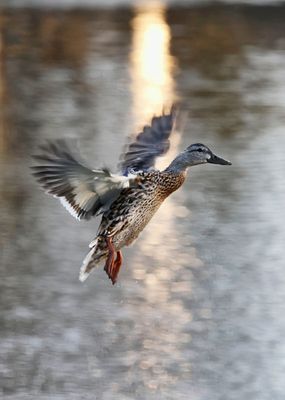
[131,4,175,124]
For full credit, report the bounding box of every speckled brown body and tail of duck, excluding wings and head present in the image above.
[80,170,186,283]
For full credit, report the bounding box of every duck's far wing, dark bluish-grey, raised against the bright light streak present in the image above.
[120,107,176,175]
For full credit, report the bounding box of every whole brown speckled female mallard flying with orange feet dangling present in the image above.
[32,109,231,284]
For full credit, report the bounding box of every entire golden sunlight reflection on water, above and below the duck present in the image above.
[130,4,202,378]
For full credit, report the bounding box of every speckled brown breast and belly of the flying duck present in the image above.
[98,171,185,250]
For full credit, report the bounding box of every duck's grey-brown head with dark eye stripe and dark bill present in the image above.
[184,143,232,167]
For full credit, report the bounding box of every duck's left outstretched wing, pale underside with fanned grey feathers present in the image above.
[32,140,135,219]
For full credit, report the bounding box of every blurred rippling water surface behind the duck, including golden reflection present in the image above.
[0,5,285,400]
